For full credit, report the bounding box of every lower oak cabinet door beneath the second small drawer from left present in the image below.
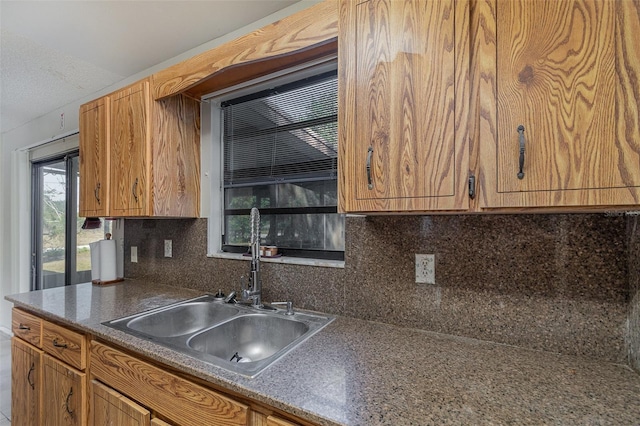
[42,354,87,426]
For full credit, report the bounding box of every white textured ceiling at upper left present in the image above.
[0,0,299,132]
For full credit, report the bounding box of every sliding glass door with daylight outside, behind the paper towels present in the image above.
[32,152,108,290]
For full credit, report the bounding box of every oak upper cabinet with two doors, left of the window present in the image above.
[80,79,200,217]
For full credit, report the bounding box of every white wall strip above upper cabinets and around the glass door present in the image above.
[0,0,321,328]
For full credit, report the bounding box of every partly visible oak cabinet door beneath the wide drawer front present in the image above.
[89,380,151,426]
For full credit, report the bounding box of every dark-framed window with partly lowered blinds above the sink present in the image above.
[221,70,344,260]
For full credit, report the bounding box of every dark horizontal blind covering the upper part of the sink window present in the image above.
[221,71,338,188]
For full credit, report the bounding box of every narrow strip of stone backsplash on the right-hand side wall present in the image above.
[627,216,640,373]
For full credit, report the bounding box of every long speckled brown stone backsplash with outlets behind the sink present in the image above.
[125,214,640,363]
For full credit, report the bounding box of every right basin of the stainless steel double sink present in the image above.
[187,314,309,363]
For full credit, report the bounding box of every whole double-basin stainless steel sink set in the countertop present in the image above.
[103,295,334,377]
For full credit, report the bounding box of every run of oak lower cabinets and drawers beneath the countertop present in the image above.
[11,308,311,426]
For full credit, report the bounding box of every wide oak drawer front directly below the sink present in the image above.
[91,341,248,426]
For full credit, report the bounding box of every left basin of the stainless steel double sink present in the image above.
[126,302,238,337]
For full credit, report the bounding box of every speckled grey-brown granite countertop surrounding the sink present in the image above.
[6,280,640,426]
